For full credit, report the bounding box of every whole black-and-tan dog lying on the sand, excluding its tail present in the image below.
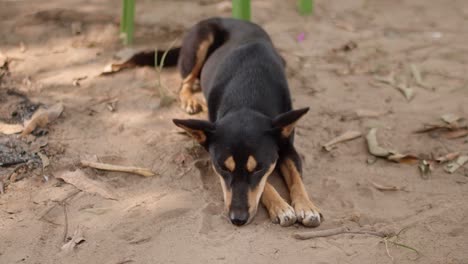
[166,18,321,226]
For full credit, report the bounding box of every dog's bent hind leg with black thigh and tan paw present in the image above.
[179,22,217,114]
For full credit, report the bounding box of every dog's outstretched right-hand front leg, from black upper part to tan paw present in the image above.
[279,143,323,227]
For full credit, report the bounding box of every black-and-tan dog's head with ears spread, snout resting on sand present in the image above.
[173,108,309,225]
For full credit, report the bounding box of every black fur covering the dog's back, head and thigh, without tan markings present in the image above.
[170,18,308,224]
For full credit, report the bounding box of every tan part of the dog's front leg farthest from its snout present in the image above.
[280,159,321,227]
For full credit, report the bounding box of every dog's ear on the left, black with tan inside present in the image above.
[172,119,215,147]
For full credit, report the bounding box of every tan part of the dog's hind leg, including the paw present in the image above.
[179,34,213,114]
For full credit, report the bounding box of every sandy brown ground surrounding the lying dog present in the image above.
[0,0,468,264]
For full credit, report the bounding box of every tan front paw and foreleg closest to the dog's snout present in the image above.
[262,183,296,226]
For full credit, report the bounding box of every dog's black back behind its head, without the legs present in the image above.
[200,18,291,121]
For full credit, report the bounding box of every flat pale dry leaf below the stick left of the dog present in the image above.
[56,170,117,200]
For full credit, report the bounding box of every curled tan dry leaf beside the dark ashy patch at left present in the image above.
[21,103,63,136]
